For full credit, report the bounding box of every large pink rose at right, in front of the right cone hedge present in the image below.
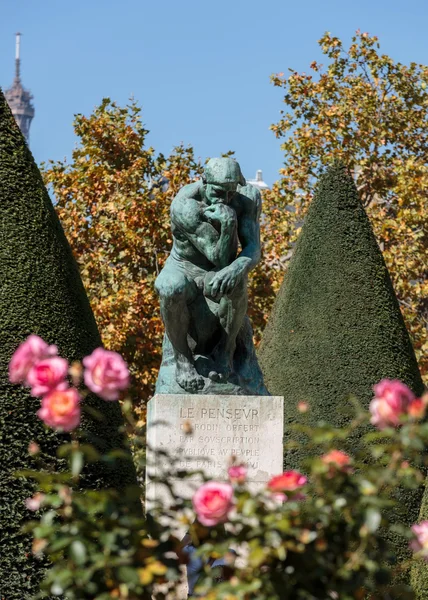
[369,379,415,429]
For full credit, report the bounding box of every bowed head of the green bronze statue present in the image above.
[202,158,245,204]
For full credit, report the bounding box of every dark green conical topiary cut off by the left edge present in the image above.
[0,90,135,600]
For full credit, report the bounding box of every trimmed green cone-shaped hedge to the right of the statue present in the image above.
[259,162,423,584]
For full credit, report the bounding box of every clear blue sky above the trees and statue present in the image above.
[0,0,428,184]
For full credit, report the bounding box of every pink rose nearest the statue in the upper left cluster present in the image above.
[83,348,129,400]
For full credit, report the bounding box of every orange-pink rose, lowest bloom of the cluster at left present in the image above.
[37,388,80,431]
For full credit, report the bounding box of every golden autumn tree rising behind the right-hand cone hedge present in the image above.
[259,31,428,378]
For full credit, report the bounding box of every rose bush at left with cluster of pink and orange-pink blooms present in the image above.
[9,336,180,600]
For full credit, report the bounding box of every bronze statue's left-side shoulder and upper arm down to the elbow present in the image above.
[171,186,226,266]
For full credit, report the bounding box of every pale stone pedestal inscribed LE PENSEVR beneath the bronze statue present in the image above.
[146,394,284,506]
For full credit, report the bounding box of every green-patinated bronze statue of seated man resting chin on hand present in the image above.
[156,158,268,396]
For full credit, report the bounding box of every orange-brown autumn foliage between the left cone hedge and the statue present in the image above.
[43,99,200,399]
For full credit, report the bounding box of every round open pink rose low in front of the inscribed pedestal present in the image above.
[192,481,233,527]
